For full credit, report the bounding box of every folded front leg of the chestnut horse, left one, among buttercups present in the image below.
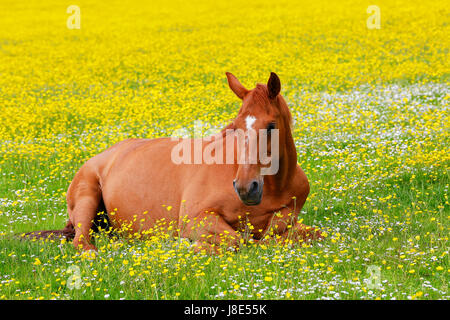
[179,211,242,253]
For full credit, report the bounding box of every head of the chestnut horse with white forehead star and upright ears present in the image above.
[227,72,292,205]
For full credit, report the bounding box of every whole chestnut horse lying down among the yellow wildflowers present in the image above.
[27,73,321,250]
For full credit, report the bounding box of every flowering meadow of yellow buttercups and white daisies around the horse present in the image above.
[0,0,450,299]
